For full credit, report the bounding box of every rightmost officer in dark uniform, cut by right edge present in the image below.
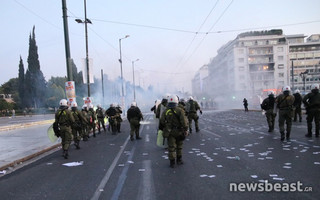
[303,84,320,137]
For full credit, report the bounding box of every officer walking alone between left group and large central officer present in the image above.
[127,102,143,141]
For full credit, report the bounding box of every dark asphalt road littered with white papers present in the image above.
[0,111,320,200]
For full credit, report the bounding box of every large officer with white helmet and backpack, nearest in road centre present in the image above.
[159,95,188,168]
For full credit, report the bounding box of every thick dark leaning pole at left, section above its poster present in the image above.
[62,0,73,81]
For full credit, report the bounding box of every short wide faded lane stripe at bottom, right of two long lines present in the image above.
[137,160,156,200]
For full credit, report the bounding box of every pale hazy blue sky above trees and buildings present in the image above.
[0,0,320,92]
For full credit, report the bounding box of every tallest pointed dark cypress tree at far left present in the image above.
[25,26,47,108]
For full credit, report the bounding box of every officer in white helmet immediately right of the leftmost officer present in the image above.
[71,101,87,149]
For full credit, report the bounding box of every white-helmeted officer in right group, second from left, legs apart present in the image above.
[276,86,294,141]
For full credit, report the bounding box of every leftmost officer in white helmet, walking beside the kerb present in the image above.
[55,99,74,159]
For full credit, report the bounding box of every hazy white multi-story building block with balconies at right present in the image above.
[193,30,320,105]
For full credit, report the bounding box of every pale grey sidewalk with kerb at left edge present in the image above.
[0,119,60,175]
